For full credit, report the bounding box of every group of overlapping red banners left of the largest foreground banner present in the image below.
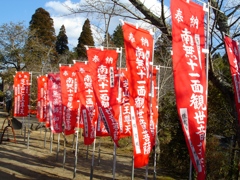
[14,23,158,168]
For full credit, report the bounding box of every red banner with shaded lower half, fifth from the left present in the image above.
[74,62,98,145]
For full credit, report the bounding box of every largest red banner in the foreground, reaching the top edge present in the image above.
[171,0,207,180]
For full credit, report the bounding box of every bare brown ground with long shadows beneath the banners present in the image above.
[0,110,161,180]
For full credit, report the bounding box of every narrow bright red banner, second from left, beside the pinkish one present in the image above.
[37,76,48,122]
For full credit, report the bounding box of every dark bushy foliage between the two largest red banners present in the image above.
[159,93,190,178]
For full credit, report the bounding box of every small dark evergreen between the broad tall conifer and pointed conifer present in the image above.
[56,25,69,54]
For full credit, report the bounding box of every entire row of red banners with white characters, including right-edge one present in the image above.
[14,0,240,176]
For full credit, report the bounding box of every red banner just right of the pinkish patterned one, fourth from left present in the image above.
[60,66,80,135]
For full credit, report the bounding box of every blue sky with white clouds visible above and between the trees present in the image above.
[0,0,166,48]
